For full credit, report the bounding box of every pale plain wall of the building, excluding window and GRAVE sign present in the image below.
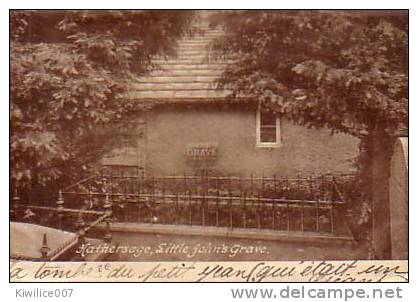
[145,104,358,175]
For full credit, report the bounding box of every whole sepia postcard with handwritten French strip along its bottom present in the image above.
[9,10,409,282]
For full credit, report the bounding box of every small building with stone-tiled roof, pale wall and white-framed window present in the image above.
[103,13,358,175]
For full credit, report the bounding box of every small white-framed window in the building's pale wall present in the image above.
[256,109,280,148]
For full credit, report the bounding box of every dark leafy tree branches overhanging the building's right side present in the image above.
[212,11,408,138]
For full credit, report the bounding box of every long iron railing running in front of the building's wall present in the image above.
[58,171,352,235]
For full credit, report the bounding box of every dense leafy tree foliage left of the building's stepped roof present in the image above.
[10,11,193,193]
